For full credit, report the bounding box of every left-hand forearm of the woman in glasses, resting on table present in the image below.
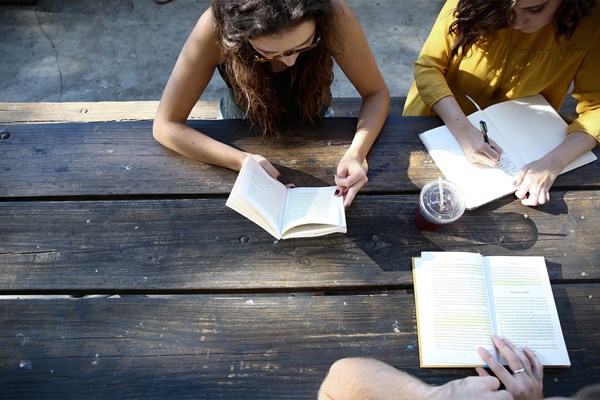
[153,120,248,171]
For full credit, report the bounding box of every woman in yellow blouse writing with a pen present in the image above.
[404,0,600,206]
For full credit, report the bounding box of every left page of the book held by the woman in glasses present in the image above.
[226,157,288,238]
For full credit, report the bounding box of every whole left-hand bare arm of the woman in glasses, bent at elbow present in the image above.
[153,9,279,178]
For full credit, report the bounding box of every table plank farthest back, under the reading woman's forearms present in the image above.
[0,117,600,198]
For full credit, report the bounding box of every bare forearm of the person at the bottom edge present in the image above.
[318,358,432,400]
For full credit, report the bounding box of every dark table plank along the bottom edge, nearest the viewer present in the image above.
[0,285,600,400]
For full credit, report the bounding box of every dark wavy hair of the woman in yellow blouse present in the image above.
[448,0,596,59]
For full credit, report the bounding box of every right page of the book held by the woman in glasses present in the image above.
[282,186,345,232]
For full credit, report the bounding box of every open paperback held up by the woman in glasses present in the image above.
[226,157,346,239]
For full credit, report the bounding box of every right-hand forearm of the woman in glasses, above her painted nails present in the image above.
[345,90,390,162]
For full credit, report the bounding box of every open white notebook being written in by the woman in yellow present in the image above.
[419,95,596,210]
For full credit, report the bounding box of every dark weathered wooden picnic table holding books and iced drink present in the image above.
[0,101,600,399]
